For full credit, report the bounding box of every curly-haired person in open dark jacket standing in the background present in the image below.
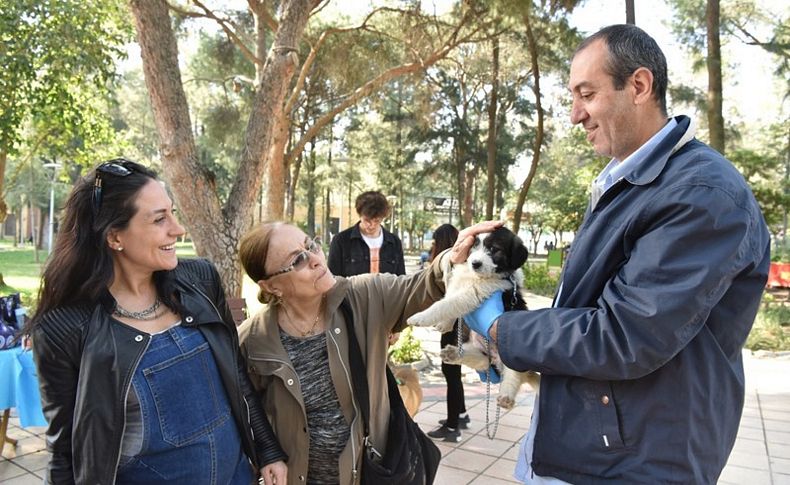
[328,191,406,276]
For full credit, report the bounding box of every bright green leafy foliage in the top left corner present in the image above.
[0,0,130,153]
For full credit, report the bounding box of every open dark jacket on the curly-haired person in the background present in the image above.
[327,222,406,276]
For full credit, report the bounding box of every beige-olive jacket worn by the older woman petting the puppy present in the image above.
[239,253,447,485]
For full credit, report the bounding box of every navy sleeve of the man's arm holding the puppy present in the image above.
[497,186,767,380]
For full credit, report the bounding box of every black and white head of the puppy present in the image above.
[467,227,529,274]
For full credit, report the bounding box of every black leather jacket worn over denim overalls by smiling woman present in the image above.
[33,260,287,485]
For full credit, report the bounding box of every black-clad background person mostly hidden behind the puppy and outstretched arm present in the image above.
[426,224,470,443]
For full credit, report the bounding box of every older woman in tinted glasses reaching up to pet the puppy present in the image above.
[240,222,499,485]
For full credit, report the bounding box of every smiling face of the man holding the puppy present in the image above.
[568,40,641,160]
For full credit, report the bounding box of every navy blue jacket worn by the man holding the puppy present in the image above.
[497,117,770,484]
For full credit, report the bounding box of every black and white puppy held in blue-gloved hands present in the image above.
[407,227,539,409]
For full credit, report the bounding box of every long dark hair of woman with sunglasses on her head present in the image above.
[28,158,169,333]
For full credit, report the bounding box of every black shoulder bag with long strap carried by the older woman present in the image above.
[340,299,442,485]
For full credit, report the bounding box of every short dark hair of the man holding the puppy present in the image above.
[573,24,669,115]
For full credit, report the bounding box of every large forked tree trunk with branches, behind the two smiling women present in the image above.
[130,0,488,295]
